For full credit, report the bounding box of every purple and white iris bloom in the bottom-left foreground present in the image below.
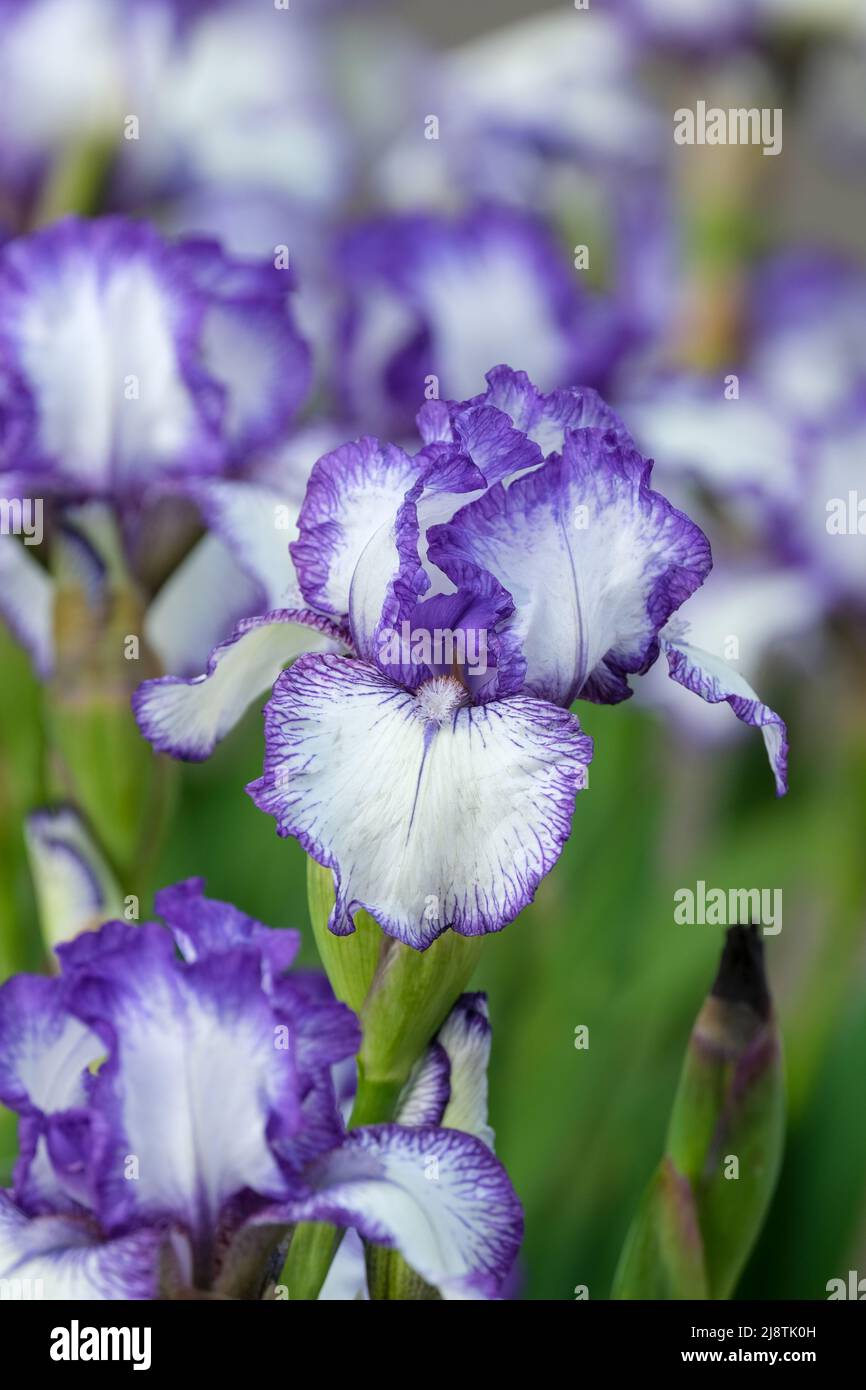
[0,880,523,1300]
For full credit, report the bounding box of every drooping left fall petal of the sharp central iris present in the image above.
[132,610,346,762]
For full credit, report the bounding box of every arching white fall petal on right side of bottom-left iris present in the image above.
[283,1125,523,1300]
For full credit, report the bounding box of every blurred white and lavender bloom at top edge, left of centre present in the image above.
[115,0,350,210]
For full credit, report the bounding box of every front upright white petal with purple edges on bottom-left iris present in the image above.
[60,923,300,1256]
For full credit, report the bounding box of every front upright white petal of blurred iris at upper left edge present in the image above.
[0,218,222,495]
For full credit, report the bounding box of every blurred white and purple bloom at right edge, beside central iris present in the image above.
[623,250,866,609]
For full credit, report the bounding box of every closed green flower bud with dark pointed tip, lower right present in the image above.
[613,926,784,1298]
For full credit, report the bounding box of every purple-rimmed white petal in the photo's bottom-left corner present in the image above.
[0,1191,164,1301]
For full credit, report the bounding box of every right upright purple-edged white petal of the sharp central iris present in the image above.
[428,428,712,705]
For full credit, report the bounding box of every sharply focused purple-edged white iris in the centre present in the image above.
[135,367,787,949]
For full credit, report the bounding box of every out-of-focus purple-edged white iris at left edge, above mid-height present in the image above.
[0,217,310,673]
